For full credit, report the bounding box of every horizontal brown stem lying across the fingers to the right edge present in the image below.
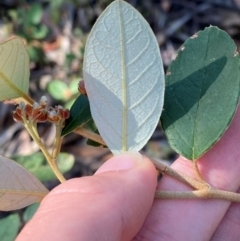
[155,189,240,202]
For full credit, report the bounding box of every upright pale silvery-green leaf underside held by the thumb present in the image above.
[84,0,164,154]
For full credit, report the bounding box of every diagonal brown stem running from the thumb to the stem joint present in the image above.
[151,159,206,190]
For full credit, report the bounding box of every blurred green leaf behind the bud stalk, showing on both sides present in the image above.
[14,153,74,182]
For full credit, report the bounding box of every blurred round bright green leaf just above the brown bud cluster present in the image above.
[47,80,71,100]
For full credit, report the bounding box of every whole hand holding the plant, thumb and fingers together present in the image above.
[16,106,240,241]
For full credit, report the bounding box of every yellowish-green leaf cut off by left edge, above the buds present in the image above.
[0,38,30,101]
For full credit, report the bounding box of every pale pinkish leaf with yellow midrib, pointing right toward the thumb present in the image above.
[0,156,48,211]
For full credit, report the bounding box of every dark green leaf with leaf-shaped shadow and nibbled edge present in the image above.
[161,27,240,160]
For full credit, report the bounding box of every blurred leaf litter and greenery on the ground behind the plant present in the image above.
[0,0,240,237]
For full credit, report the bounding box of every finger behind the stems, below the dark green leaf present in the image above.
[135,106,240,241]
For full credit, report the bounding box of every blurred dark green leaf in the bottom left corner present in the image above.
[0,214,21,241]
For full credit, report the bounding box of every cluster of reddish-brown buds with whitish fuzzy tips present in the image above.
[12,96,69,124]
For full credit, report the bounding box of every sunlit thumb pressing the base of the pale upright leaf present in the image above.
[17,154,157,241]
